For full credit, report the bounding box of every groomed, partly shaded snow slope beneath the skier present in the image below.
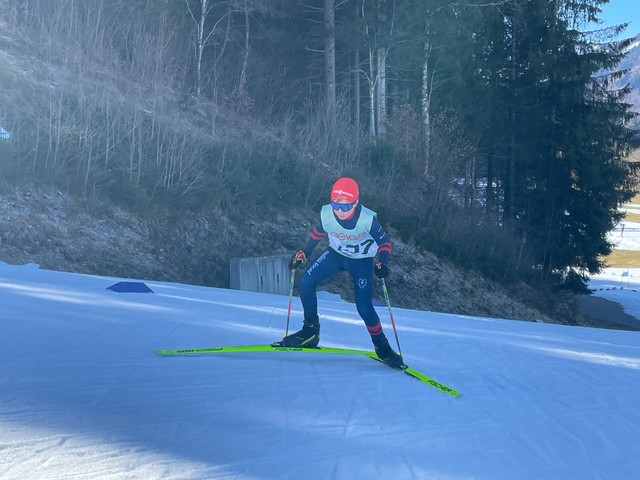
[0,263,640,480]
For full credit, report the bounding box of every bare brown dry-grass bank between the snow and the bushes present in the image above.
[0,182,571,321]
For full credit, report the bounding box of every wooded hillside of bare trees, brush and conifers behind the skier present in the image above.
[0,0,635,323]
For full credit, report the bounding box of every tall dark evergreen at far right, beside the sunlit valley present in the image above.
[504,0,633,282]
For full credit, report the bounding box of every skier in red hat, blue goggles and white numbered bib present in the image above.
[278,177,404,369]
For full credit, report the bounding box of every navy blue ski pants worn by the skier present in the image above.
[299,248,382,335]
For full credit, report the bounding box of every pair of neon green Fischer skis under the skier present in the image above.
[154,344,461,397]
